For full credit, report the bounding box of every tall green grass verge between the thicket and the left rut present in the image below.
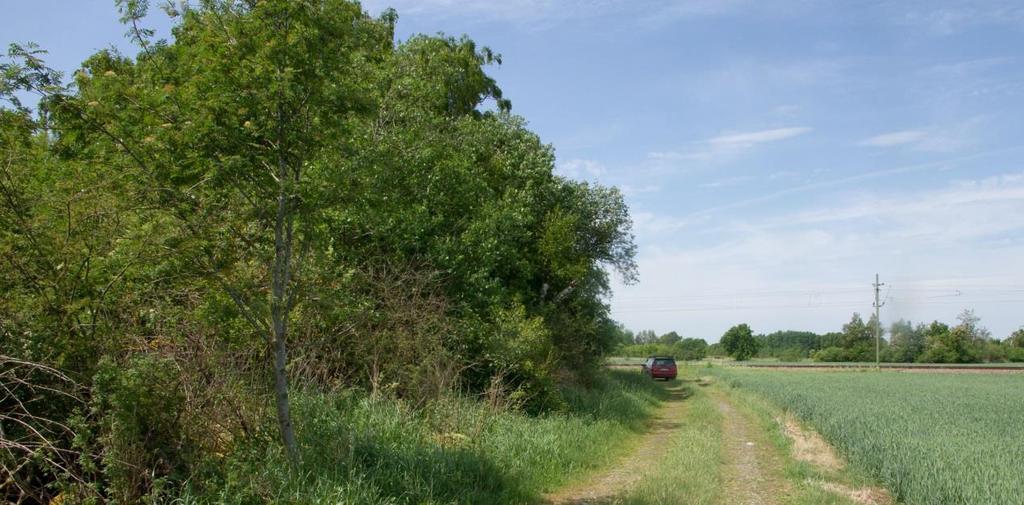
[177,371,667,504]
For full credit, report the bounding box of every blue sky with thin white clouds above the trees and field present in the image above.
[6,0,1024,340]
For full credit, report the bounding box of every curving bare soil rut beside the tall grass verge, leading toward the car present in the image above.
[545,385,689,505]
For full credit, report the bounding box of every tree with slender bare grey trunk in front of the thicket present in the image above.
[37,0,391,459]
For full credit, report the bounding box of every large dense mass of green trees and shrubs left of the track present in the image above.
[0,0,636,502]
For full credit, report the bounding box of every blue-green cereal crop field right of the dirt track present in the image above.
[709,368,1024,504]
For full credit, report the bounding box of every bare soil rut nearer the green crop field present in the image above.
[712,390,784,505]
